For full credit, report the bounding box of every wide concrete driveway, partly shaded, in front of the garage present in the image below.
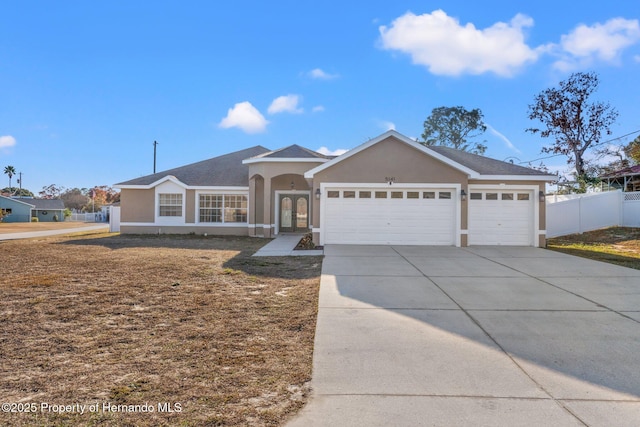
[288,245,640,426]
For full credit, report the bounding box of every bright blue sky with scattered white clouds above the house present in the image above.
[0,0,640,193]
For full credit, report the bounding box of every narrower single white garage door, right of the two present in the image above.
[468,190,534,246]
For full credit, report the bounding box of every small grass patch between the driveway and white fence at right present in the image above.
[547,227,640,270]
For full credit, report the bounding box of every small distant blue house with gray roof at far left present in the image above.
[0,196,64,222]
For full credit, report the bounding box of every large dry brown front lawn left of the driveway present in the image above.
[0,234,321,426]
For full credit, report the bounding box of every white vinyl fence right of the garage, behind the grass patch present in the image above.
[546,190,640,237]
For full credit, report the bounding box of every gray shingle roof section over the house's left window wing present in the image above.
[116,146,269,187]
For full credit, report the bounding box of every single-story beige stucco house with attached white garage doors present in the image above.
[116,131,556,246]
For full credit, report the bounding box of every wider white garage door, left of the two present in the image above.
[321,187,456,245]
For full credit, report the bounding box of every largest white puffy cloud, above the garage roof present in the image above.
[379,10,547,77]
